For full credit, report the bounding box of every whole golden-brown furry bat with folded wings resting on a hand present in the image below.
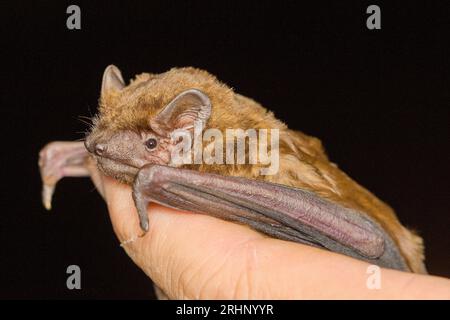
[39,65,426,273]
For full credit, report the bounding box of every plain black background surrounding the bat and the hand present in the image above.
[0,1,450,299]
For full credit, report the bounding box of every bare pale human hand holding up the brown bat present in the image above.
[90,162,450,299]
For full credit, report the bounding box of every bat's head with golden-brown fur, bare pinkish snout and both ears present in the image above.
[85,65,218,184]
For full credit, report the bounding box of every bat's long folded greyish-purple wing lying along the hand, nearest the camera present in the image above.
[133,165,409,270]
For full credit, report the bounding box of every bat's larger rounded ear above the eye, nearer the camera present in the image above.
[150,89,211,136]
